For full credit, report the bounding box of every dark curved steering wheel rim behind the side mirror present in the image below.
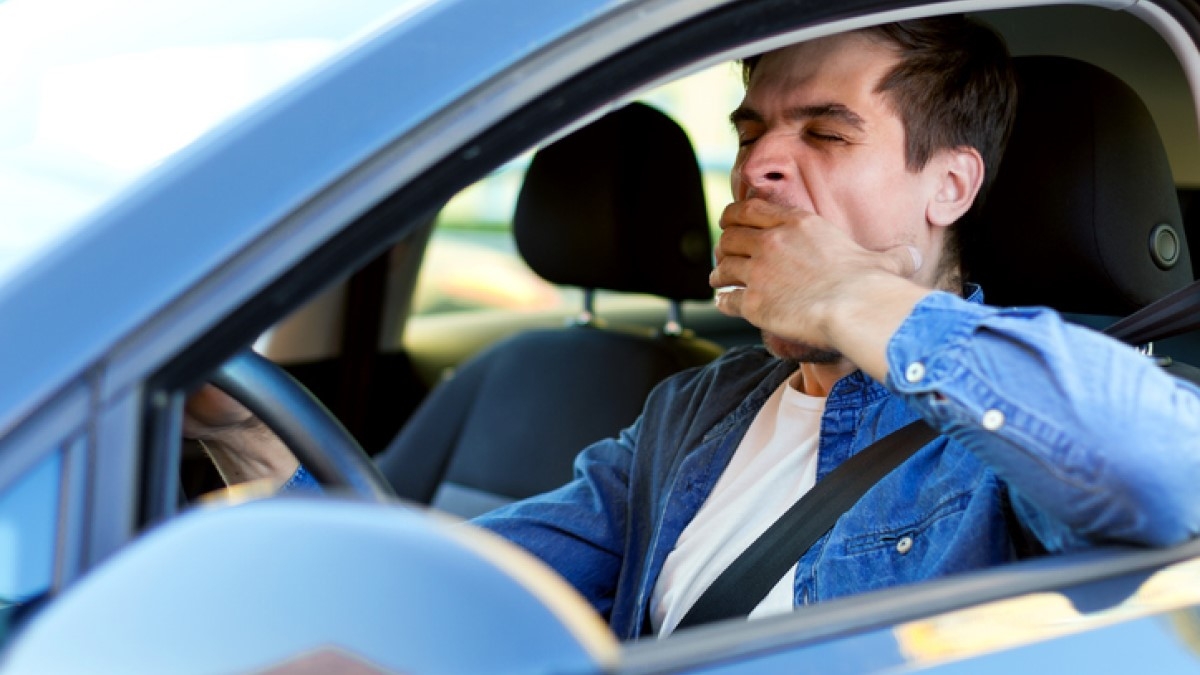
[210,348,396,502]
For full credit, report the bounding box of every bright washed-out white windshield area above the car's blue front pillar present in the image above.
[0,0,428,283]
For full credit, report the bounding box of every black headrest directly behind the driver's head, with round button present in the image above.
[961,56,1192,315]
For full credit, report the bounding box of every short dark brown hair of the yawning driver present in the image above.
[742,14,1016,281]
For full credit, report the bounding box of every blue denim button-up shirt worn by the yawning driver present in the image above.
[475,289,1200,639]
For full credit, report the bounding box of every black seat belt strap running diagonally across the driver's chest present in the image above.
[679,420,937,628]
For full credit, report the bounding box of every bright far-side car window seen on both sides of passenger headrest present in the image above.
[413,64,742,325]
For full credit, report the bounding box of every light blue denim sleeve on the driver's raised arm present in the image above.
[887,292,1200,550]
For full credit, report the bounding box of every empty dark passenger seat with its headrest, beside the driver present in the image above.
[377,103,721,516]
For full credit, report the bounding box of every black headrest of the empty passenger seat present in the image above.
[512,103,713,300]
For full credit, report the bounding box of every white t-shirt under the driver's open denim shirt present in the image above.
[650,378,826,638]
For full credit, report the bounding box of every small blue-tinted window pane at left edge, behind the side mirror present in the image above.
[0,453,62,644]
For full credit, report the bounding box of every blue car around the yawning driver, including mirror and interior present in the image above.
[0,0,1200,674]
